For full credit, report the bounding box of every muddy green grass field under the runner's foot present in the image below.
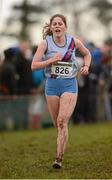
[0,123,112,179]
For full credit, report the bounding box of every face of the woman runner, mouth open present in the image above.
[51,17,67,37]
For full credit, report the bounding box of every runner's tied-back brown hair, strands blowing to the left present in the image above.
[42,14,67,39]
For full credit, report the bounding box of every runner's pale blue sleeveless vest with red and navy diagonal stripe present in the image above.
[43,35,79,79]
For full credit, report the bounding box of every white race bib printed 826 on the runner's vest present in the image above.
[51,62,73,76]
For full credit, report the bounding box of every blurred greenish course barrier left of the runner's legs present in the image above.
[0,95,53,131]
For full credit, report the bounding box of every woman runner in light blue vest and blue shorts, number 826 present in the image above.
[31,14,91,168]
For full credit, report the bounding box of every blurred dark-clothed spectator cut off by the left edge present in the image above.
[0,48,17,95]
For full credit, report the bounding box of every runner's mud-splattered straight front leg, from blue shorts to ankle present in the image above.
[57,92,77,159]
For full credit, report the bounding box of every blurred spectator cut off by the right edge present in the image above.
[99,39,112,120]
